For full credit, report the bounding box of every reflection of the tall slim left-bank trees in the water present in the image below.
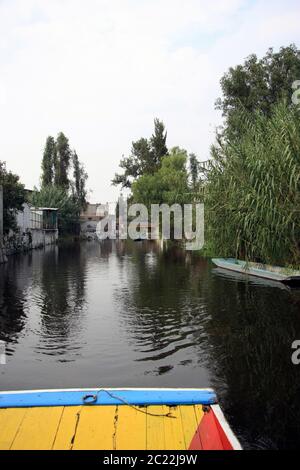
[37,244,86,361]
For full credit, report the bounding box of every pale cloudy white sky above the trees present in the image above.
[0,0,300,203]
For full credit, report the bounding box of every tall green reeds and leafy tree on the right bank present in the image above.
[204,45,300,267]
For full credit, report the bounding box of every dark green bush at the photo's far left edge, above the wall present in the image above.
[0,161,26,234]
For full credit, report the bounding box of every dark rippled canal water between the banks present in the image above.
[0,241,300,449]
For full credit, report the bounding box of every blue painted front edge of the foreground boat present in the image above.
[0,388,217,408]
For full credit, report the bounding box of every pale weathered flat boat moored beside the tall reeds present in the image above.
[212,258,300,286]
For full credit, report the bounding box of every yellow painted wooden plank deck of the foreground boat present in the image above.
[0,405,203,450]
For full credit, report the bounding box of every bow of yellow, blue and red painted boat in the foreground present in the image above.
[0,389,241,450]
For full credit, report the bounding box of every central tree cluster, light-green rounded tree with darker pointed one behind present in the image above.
[112,119,199,206]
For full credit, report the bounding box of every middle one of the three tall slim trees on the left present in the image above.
[54,132,71,189]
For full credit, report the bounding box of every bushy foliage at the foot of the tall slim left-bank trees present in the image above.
[30,185,80,232]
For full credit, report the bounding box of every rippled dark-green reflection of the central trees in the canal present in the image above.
[115,242,210,375]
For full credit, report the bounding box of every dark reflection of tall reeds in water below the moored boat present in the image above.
[203,268,300,448]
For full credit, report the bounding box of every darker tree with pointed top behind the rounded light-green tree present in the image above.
[112,119,168,188]
